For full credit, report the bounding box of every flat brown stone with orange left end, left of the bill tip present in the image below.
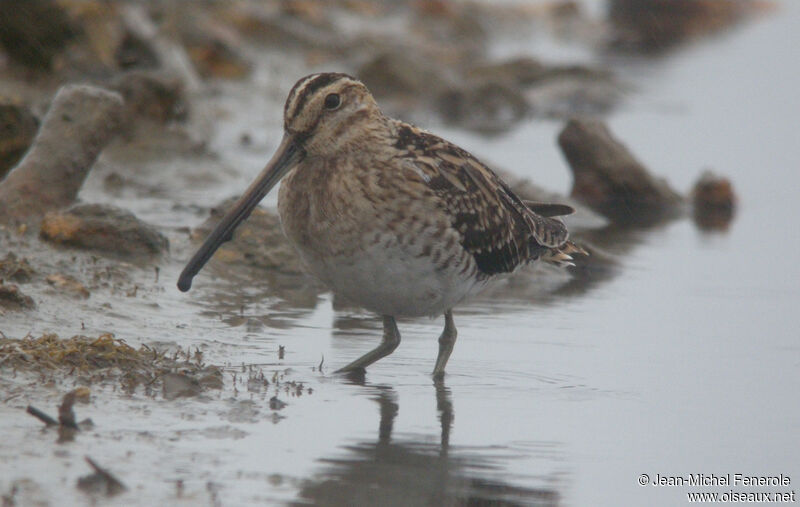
[40,204,169,257]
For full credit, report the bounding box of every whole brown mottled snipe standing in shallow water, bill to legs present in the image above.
[178,73,581,377]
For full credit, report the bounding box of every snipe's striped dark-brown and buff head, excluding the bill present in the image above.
[283,73,383,156]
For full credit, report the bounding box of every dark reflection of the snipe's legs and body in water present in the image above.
[290,377,560,507]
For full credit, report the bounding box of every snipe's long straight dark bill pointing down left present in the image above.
[178,134,302,292]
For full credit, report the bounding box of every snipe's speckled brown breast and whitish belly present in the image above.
[278,157,476,315]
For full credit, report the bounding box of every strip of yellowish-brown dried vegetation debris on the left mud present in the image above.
[0,334,222,394]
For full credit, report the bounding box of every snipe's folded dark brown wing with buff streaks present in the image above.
[397,127,568,275]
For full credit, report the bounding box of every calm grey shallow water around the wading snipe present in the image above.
[0,2,800,505]
